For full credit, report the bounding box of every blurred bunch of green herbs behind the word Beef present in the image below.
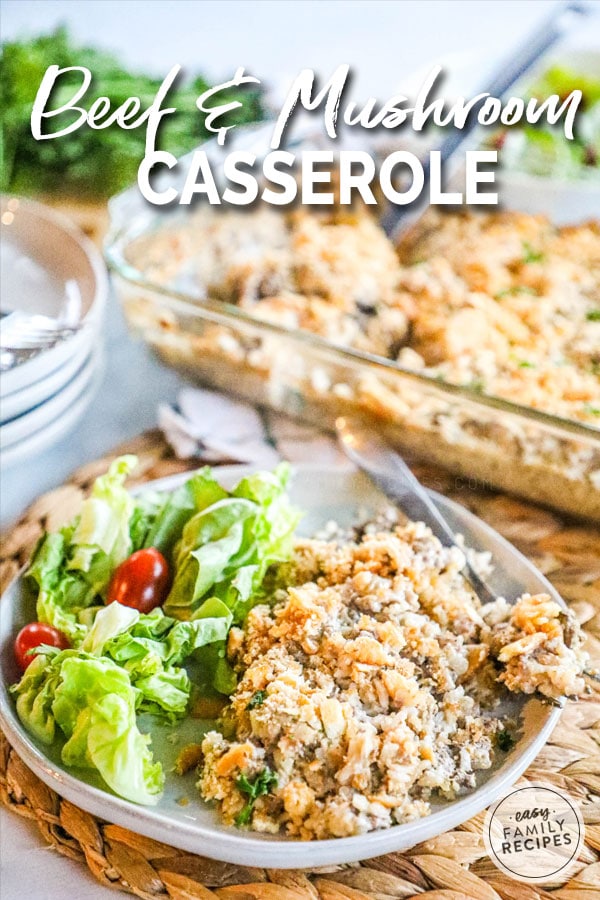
[0,28,264,197]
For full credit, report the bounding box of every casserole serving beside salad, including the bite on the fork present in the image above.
[199,523,583,840]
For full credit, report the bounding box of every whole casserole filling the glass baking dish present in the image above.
[118,203,600,518]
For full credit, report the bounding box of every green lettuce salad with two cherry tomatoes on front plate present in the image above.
[11,456,299,804]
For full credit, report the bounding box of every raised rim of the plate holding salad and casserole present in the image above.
[0,463,566,868]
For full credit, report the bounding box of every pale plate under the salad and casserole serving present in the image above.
[0,466,562,868]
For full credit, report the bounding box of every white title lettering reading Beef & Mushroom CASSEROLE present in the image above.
[31,65,582,206]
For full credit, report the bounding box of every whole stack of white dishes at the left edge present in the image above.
[0,197,107,468]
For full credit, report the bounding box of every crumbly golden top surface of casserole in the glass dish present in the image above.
[132,208,600,426]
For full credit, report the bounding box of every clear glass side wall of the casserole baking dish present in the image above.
[106,129,600,521]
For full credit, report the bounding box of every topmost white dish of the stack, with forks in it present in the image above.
[0,196,108,397]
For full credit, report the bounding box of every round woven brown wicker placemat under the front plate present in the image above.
[0,432,600,900]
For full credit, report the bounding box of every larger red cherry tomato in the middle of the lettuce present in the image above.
[106,547,169,613]
